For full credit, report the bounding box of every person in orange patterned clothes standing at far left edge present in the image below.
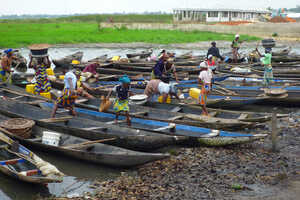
[0,49,15,83]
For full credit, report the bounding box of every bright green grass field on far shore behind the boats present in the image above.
[0,22,260,48]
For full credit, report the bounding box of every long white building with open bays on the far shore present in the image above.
[173,8,271,22]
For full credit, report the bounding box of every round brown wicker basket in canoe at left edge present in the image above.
[0,118,35,139]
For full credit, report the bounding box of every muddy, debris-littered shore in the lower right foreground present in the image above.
[45,113,300,200]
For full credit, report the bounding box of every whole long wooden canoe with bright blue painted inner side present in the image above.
[41,103,266,146]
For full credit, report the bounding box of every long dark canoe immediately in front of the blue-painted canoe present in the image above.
[0,99,183,151]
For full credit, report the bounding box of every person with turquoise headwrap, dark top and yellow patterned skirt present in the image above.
[106,75,133,126]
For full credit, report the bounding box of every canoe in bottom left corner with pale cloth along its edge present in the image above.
[0,131,64,184]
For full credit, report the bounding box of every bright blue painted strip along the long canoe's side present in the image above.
[42,102,253,137]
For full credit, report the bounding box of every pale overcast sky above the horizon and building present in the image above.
[0,0,300,15]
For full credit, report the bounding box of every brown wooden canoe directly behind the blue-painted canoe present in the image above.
[0,87,278,130]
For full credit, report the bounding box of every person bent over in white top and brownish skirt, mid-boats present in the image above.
[144,79,180,103]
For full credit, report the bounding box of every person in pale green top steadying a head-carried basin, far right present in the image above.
[256,48,274,87]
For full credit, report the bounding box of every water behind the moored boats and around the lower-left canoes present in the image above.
[0,48,300,200]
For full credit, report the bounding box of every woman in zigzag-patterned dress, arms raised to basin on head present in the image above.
[28,56,52,94]
